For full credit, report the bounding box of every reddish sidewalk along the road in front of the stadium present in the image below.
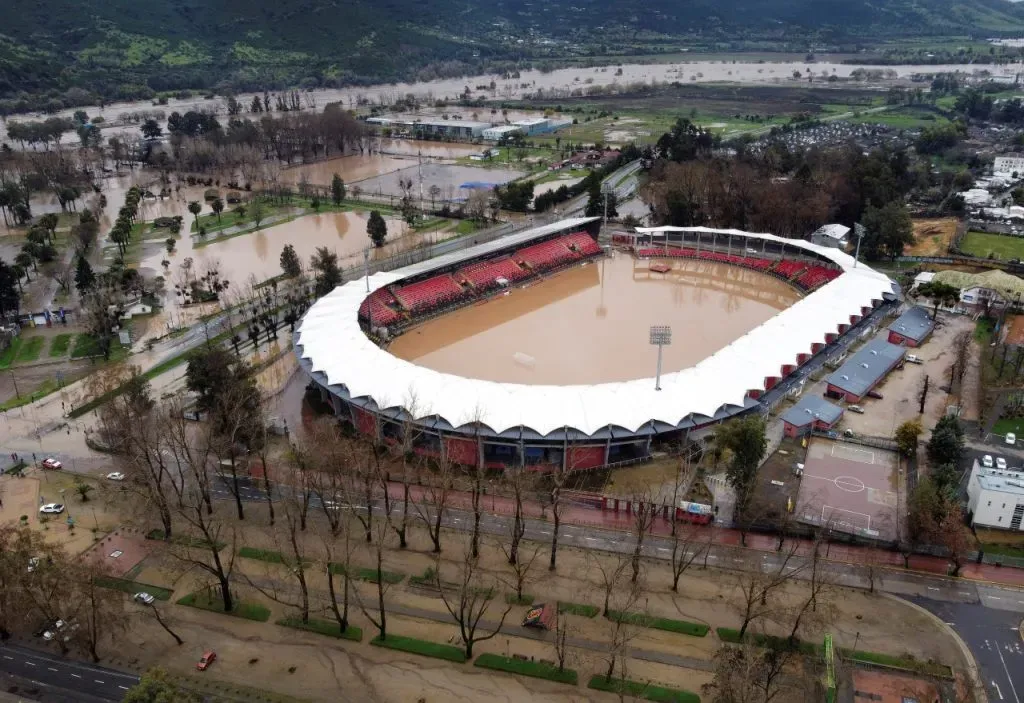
[388,482,1024,587]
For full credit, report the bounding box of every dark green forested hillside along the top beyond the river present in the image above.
[0,0,1024,112]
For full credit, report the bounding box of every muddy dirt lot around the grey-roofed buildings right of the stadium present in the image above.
[843,313,980,439]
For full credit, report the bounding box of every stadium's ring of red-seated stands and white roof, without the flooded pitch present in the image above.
[295,218,898,470]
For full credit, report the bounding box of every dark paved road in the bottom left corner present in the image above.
[0,644,138,703]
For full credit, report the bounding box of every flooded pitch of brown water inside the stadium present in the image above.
[389,254,800,385]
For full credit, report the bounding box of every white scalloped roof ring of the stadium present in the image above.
[296,223,893,435]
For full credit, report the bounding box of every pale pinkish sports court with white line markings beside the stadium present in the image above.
[795,438,898,539]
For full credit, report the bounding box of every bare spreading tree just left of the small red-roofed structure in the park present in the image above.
[434,539,512,659]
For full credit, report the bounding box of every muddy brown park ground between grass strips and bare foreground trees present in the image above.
[86,506,962,702]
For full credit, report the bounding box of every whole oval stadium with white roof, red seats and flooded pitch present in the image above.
[296,218,898,471]
